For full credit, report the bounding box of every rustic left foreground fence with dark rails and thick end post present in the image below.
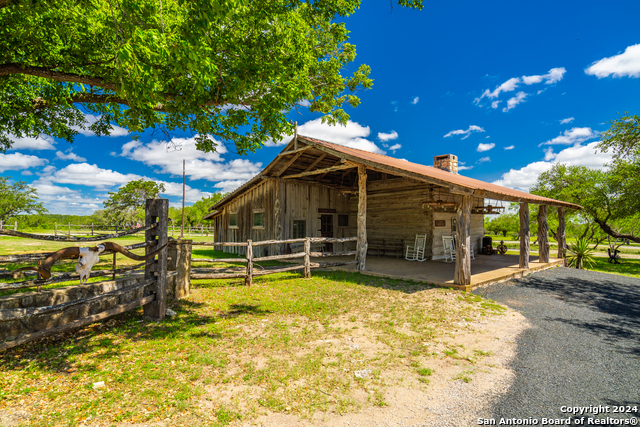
[0,199,169,350]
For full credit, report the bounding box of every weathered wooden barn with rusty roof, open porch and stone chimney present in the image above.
[205,135,580,284]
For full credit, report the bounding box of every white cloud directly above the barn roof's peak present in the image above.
[272,119,394,154]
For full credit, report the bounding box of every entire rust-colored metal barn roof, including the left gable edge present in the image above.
[207,135,582,212]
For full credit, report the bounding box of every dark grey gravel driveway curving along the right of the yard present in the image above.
[474,268,640,425]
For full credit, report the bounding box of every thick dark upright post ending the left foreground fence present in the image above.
[144,199,169,321]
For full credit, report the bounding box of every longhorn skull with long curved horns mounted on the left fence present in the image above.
[14,242,167,283]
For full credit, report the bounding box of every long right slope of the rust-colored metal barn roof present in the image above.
[298,135,582,209]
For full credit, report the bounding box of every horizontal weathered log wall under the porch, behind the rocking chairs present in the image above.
[349,177,433,257]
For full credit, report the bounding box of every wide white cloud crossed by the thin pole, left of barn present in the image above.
[120,138,262,181]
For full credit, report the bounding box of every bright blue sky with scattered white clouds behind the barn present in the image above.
[0,1,640,214]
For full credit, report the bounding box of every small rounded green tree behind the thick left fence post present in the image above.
[103,179,165,226]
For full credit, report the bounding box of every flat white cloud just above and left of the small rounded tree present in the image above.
[49,163,142,188]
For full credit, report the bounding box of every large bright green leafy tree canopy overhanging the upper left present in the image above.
[0,0,423,154]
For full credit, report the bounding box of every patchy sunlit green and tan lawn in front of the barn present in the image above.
[0,239,504,426]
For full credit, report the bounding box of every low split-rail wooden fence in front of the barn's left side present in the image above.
[190,237,358,286]
